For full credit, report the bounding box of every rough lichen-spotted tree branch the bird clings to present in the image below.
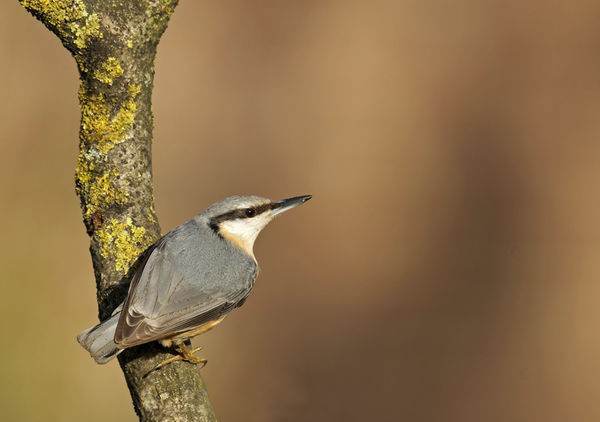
[19,0,216,421]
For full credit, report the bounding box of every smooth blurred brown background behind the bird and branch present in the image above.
[0,0,600,422]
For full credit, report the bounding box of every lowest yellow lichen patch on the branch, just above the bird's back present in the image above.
[95,217,153,274]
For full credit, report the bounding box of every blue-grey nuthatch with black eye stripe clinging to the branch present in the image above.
[77,195,312,369]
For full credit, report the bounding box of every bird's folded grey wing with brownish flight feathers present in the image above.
[115,229,251,347]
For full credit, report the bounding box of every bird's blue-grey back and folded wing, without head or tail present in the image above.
[115,219,257,347]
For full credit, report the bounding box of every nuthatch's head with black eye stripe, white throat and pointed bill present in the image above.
[201,195,312,257]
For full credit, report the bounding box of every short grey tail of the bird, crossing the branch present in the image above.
[77,312,123,363]
